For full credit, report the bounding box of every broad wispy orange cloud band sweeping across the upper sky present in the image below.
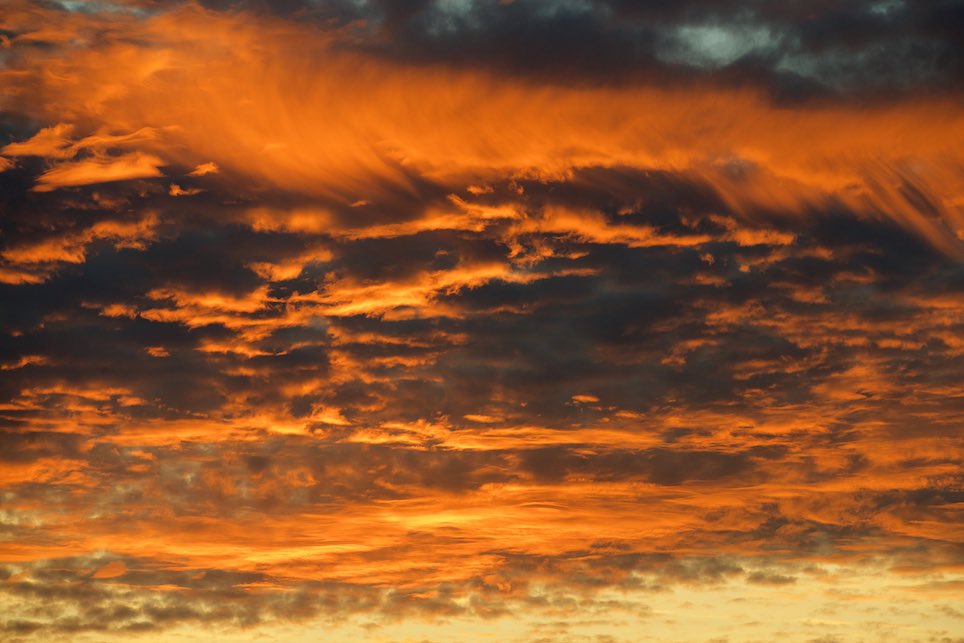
[1,7,964,256]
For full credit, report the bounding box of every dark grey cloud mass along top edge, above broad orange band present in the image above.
[186,0,964,100]
